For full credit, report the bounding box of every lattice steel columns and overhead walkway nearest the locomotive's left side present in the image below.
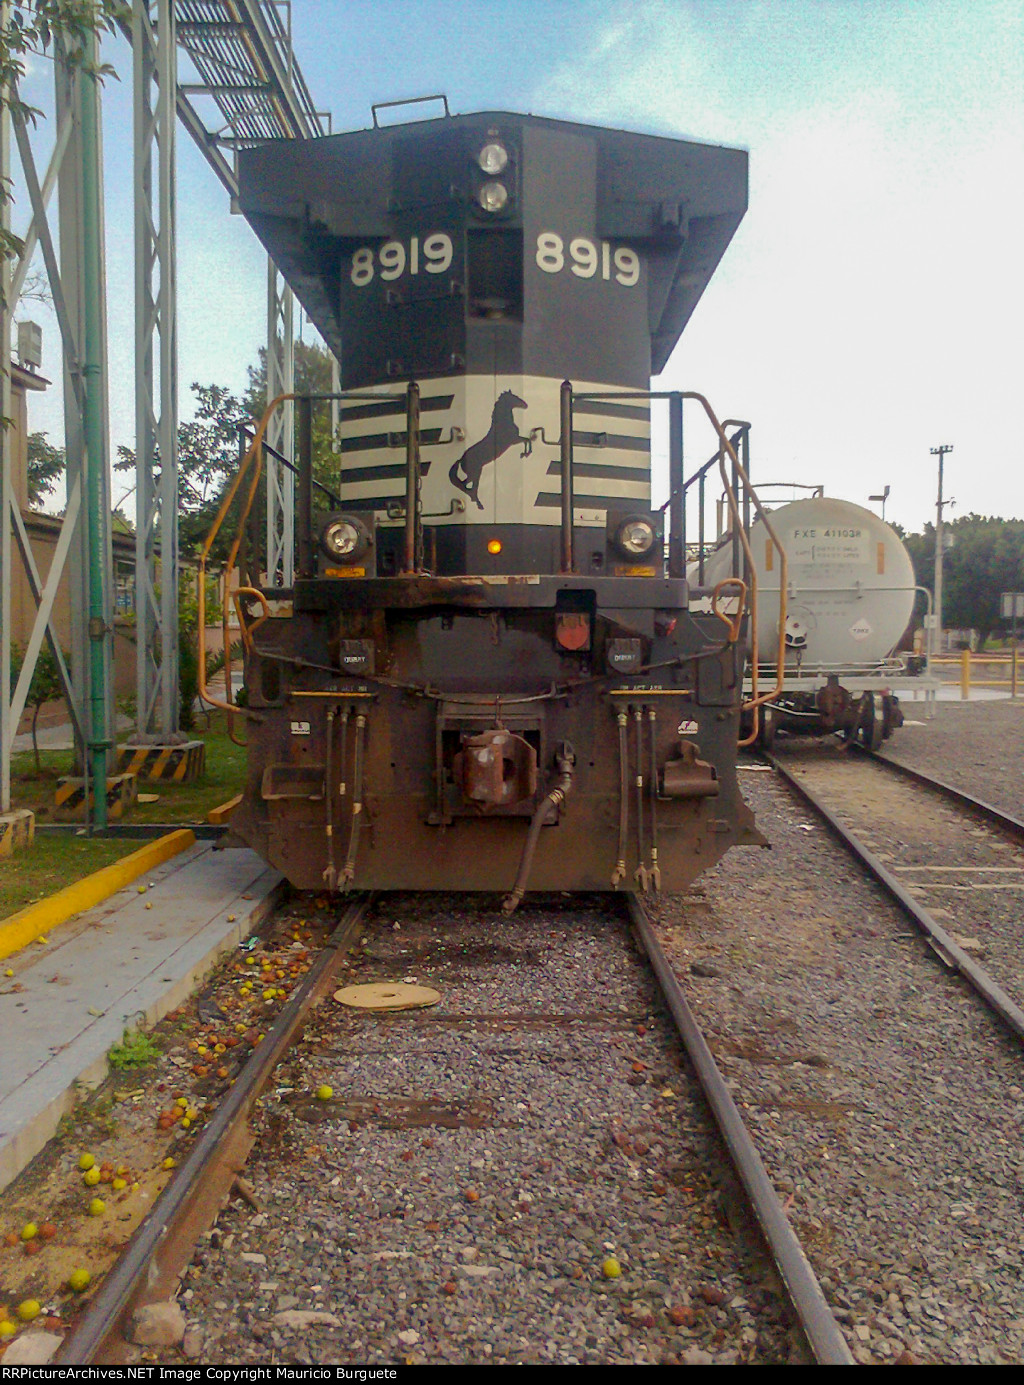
[130,0,326,741]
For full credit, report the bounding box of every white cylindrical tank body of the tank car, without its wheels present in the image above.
[705,496,915,673]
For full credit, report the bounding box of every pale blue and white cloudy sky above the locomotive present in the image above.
[14,0,1024,532]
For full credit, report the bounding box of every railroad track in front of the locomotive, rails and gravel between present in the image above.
[46,897,852,1364]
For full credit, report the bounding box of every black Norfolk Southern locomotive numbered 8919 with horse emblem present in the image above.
[216,112,763,910]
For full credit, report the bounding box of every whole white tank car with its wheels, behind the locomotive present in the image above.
[704,494,930,749]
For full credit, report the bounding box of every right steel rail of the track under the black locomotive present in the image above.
[628,895,855,1366]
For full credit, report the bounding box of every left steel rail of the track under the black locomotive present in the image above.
[55,895,373,1366]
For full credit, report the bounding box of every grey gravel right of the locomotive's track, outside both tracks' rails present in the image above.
[661,702,1024,1364]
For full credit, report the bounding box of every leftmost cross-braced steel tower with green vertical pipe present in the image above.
[0,21,112,827]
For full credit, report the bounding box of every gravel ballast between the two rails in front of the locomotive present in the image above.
[165,896,801,1364]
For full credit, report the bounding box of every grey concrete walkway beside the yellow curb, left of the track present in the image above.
[0,842,283,1188]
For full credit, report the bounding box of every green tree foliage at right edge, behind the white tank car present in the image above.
[903,514,1024,644]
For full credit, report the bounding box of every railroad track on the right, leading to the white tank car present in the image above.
[768,742,1024,1040]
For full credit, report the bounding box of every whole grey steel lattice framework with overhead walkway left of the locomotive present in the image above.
[0,0,330,827]
